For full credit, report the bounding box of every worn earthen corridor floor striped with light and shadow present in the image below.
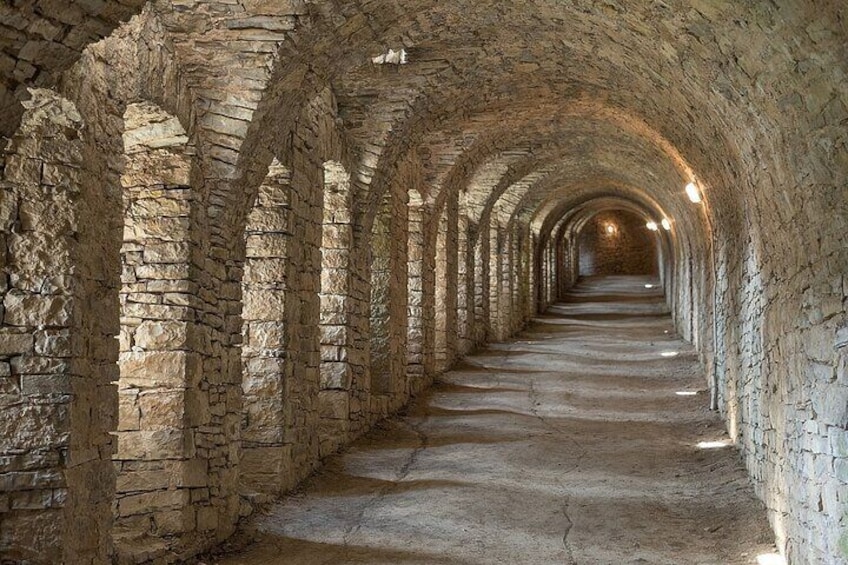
[210,277,773,565]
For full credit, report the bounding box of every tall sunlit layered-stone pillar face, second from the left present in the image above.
[115,103,205,562]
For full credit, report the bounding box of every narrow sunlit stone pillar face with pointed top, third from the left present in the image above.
[239,160,293,497]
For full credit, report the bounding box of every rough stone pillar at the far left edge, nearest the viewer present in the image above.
[0,89,120,565]
